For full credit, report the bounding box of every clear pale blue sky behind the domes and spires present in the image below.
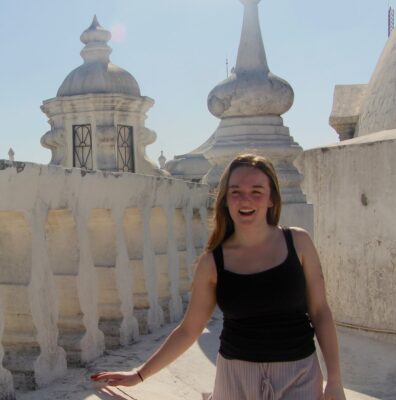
[0,0,396,164]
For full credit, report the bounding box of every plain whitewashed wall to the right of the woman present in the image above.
[298,130,396,343]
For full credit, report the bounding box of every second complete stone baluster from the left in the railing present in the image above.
[73,209,105,362]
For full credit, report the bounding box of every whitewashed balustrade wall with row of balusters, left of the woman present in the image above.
[0,161,208,400]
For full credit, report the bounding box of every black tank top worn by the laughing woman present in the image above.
[213,229,315,362]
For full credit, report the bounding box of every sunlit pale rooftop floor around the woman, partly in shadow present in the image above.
[17,313,396,400]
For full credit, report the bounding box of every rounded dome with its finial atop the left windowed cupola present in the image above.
[57,15,140,97]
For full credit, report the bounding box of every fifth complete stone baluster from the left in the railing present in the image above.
[165,204,183,322]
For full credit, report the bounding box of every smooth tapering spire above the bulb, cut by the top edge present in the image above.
[235,0,269,74]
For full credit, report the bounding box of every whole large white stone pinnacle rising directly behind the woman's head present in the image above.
[202,0,306,204]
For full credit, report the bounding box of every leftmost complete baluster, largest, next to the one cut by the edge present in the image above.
[25,200,67,386]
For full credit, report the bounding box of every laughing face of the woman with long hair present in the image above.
[226,166,273,226]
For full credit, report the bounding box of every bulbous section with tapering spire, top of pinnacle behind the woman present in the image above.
[208,0,294,118]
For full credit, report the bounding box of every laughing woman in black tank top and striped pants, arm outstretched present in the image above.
[92,154,345,400]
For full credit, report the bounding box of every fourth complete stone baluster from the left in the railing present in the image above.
[139,205,164,332]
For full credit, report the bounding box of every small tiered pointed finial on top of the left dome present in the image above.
[80,15,112,63]
